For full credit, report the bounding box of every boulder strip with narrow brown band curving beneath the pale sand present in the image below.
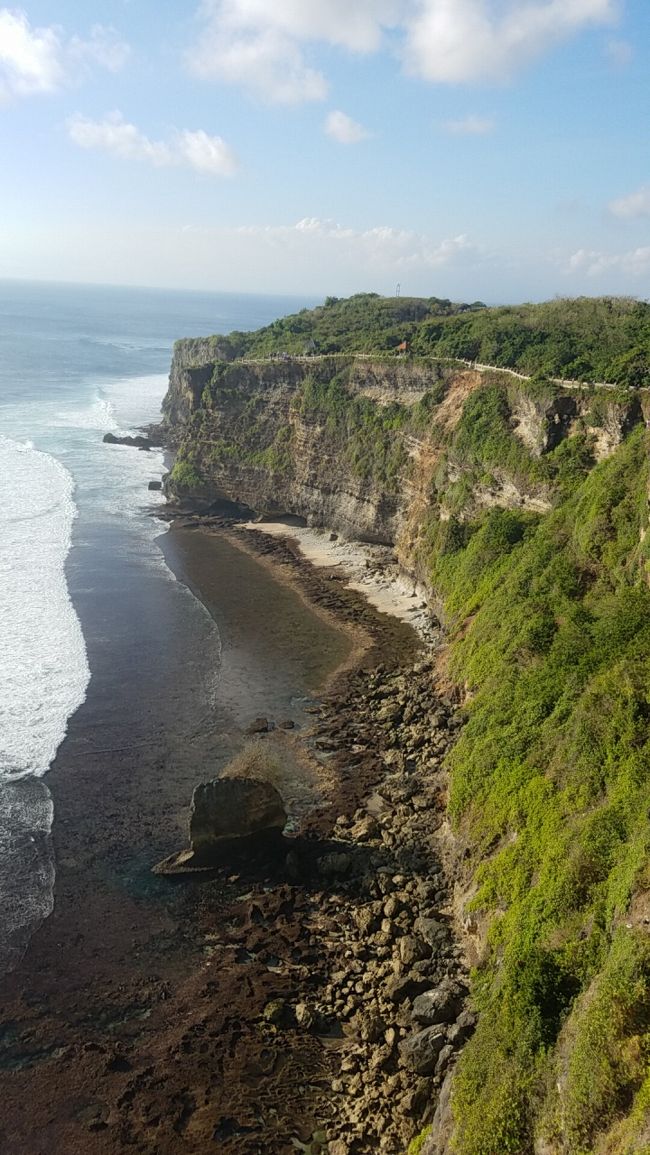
[155,519,475,1155]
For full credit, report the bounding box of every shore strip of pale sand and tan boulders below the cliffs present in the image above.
[158,515,476,1155]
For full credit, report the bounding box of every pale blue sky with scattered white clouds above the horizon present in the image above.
[0,0,650,304]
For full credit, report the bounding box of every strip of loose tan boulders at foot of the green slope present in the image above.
[275,658,475,1155]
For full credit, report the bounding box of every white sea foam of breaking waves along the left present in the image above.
[0,374,219,974]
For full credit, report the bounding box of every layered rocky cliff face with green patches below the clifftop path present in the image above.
[163,338,641,554]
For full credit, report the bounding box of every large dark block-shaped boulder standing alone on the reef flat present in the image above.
[154,777,286,874]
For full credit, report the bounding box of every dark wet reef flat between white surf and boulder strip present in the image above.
[0,528,413,1155]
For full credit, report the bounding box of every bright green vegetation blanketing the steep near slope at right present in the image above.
[417,427,650,1155]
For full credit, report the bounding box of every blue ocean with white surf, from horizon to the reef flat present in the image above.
[0,281,309,968]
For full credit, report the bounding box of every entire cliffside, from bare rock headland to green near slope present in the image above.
[159,338,650,1155]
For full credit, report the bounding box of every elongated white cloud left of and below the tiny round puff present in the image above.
[67,112,237,177]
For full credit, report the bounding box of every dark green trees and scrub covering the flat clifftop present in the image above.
[200,293,650,388]
